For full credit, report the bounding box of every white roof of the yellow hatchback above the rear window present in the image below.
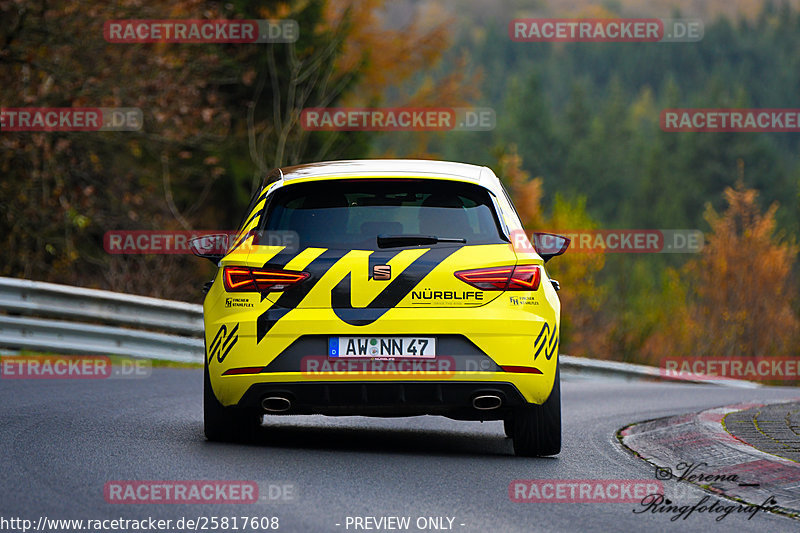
[267,159,501,194]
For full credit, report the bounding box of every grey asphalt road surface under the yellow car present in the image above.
[0,369,800,532]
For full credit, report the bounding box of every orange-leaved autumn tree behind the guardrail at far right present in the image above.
[645,181,800,362]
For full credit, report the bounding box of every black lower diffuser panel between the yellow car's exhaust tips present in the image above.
[238,381,526,420]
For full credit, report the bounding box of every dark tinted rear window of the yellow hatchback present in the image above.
[264,179,505,249]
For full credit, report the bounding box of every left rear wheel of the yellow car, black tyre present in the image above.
[203,363,261,442]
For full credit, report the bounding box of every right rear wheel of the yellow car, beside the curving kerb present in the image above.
[505,367,561,457]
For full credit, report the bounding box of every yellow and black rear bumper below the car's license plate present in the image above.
[210,334,557,408]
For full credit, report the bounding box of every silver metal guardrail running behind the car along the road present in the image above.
[0,278,759,388]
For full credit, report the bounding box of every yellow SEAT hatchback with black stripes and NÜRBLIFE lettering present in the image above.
[192,160,569,456]
